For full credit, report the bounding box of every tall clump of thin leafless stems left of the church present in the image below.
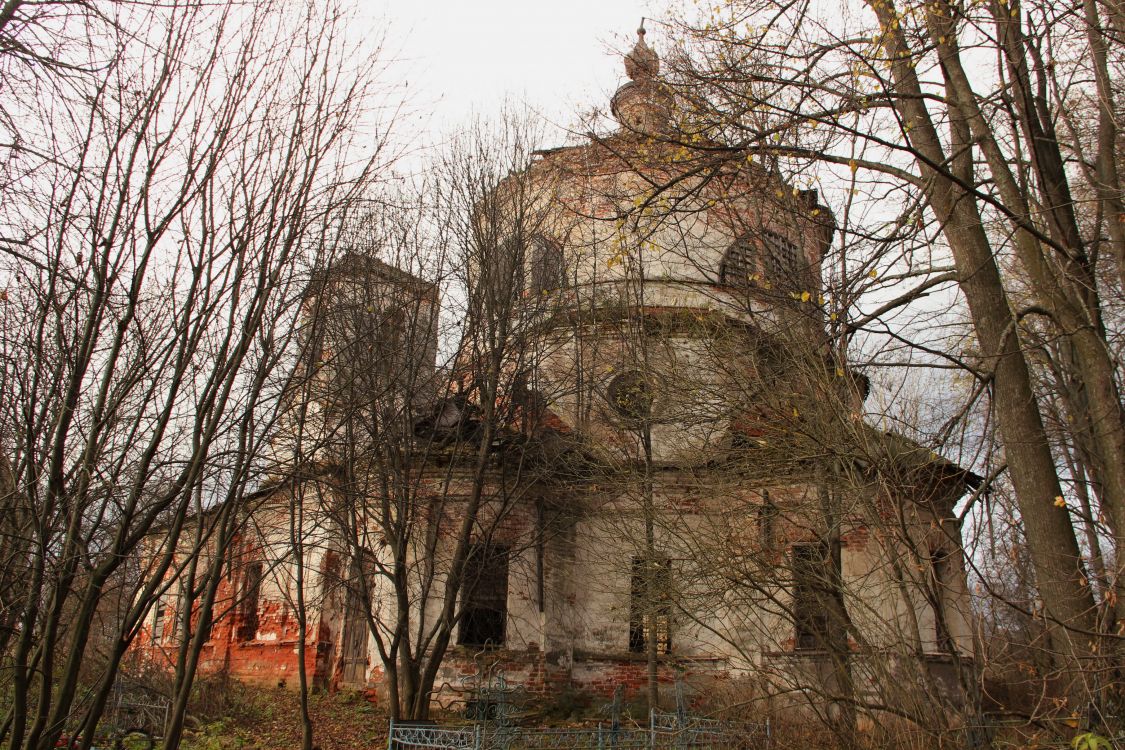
[0,2,396,749]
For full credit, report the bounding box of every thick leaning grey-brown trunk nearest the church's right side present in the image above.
[871,3,1096,711]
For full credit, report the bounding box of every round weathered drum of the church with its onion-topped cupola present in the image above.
[488,28,831,466]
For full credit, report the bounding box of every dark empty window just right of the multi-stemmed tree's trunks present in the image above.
[457,544,507,647]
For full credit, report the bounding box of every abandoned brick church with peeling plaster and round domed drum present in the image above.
[137,27,979,716]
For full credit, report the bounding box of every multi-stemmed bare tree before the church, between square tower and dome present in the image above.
[270,116,571,719]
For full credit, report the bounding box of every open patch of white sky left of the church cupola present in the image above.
[366,0,665,145]
